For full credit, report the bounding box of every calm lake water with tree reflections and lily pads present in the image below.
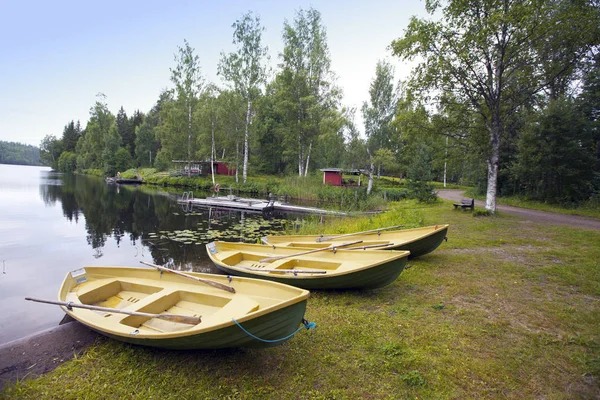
[0,164,287,344]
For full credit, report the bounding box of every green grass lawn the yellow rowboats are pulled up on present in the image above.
[0,202,600,399]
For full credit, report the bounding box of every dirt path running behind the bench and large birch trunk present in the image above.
[438,189,600,229]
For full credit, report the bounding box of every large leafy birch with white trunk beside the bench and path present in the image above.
[392,0,600,213]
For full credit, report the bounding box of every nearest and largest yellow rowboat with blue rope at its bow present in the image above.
[29,267,309,349]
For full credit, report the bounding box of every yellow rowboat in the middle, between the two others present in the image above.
[206,241,409,289]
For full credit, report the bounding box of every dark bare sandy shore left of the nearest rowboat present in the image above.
[0,321,102,390]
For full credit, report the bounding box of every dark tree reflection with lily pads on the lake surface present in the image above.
[39,172,286,272]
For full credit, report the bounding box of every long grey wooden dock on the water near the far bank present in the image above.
[177,192,348,216]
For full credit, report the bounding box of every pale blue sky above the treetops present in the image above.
[0,0,426,146]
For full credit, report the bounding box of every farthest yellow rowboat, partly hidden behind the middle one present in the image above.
[262,225,448,258]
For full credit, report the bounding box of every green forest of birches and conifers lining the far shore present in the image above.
[40,0,600,212]
